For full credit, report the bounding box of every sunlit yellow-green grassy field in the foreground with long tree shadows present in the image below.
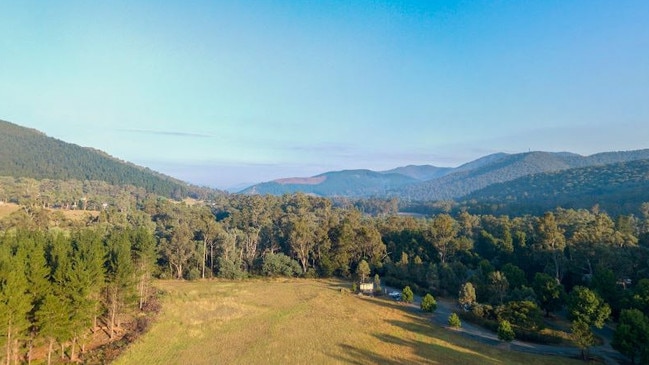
[115,279,583,365]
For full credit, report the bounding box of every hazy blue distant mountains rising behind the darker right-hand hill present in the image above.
[241,149,649,201]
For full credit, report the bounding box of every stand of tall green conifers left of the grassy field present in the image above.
[0,227,156,364]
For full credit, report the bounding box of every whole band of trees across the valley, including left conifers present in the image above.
[0,186,649,361]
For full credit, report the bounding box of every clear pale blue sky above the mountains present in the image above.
[0,0,649,188]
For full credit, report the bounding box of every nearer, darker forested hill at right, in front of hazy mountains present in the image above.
[461,159,649,215]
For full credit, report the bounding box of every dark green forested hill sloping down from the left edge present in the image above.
[0,120,220,198]
